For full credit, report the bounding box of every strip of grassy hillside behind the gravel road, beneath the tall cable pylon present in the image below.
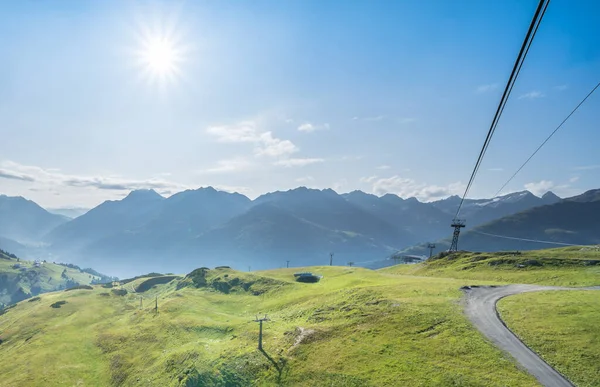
[381,247,600,286]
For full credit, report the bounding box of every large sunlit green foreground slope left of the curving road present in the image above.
[0,267,537,386]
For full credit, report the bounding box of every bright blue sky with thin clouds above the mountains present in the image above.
[0,0,600,207]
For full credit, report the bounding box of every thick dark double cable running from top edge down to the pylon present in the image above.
[454,0,550,218]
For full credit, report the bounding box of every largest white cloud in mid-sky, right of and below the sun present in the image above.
[206,121,298,157]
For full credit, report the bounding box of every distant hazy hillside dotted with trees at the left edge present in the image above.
[0,251,112,307]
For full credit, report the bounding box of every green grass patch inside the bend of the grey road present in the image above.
[498,291,600,387]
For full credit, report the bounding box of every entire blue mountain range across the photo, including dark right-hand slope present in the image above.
[0,187,600,276]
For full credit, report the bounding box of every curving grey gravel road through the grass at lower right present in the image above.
[463,285,600,387]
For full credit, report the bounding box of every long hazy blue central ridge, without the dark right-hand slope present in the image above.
[0,187,580,274]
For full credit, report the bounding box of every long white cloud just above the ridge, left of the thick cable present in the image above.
[372,175,465,202]
